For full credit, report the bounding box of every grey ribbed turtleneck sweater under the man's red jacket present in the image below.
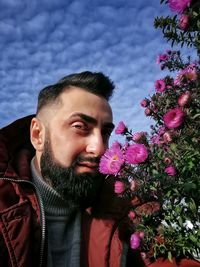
[31,160,80,267]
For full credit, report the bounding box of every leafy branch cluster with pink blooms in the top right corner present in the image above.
[154,0,200,53]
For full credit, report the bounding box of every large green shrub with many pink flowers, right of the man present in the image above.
[100,0,200,260]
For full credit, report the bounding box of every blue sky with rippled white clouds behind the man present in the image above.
[0,0,170,136]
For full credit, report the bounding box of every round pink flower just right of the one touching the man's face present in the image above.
[125,144,148,164]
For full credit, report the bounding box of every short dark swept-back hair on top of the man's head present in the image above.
[37,71,115,113]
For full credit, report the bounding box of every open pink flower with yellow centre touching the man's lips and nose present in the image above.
[99,142,124,175]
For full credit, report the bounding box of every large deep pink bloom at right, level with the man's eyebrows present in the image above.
[163,108,184,129]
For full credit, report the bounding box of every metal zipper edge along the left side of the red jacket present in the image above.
[0,177,46,267]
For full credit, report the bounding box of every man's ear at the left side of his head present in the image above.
[30,118,45,152]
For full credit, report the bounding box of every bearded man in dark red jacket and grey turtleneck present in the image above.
[0,72,200,267]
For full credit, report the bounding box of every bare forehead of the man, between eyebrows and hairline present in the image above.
[54,87,112,121]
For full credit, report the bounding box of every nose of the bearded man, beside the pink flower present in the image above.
[86,133,107,157]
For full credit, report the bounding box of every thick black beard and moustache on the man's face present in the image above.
[40,138,105,211]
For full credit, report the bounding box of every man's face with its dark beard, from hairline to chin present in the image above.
[40,88,113,207]
